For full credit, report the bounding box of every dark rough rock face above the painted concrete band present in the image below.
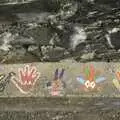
[0,0,120,63]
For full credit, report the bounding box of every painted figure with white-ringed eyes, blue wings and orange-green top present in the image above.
[77,65,105,90]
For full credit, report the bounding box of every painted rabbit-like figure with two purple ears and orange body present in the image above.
[47,69,65,96]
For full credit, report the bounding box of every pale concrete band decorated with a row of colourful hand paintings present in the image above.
[0,61,120,97]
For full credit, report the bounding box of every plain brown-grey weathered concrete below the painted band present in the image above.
[0,97,120,120]
